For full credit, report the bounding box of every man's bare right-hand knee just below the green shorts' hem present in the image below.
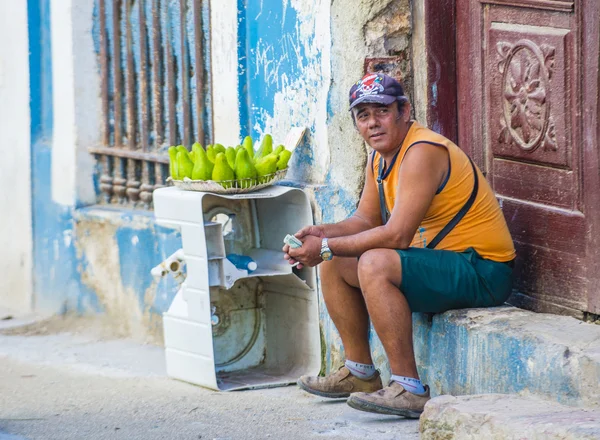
[358,249,402,285]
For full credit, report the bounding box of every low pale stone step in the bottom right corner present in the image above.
[419,394,600,440]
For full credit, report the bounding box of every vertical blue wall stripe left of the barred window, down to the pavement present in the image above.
[28,0,89,311]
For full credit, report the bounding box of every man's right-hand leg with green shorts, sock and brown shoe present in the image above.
[348,248,512,417]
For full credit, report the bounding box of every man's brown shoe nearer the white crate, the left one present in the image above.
[298,367,383,399]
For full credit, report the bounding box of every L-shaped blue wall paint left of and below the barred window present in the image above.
[28,0,181,336]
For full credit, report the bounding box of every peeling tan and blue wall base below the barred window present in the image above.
[75,208,181,343]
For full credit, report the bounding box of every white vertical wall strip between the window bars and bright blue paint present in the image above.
[210,0,241,145]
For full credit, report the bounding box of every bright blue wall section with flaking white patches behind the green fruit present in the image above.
[238,0,329,183]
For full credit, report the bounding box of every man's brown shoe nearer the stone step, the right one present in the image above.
[347,381,431,419]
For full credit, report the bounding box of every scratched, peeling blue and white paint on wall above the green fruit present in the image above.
[240,0,330,183]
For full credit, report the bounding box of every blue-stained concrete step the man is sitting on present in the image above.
[413,306,600,407]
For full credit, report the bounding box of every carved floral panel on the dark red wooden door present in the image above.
[486,23,572,168]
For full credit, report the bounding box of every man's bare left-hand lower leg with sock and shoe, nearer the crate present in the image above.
[298,257,382,398]
